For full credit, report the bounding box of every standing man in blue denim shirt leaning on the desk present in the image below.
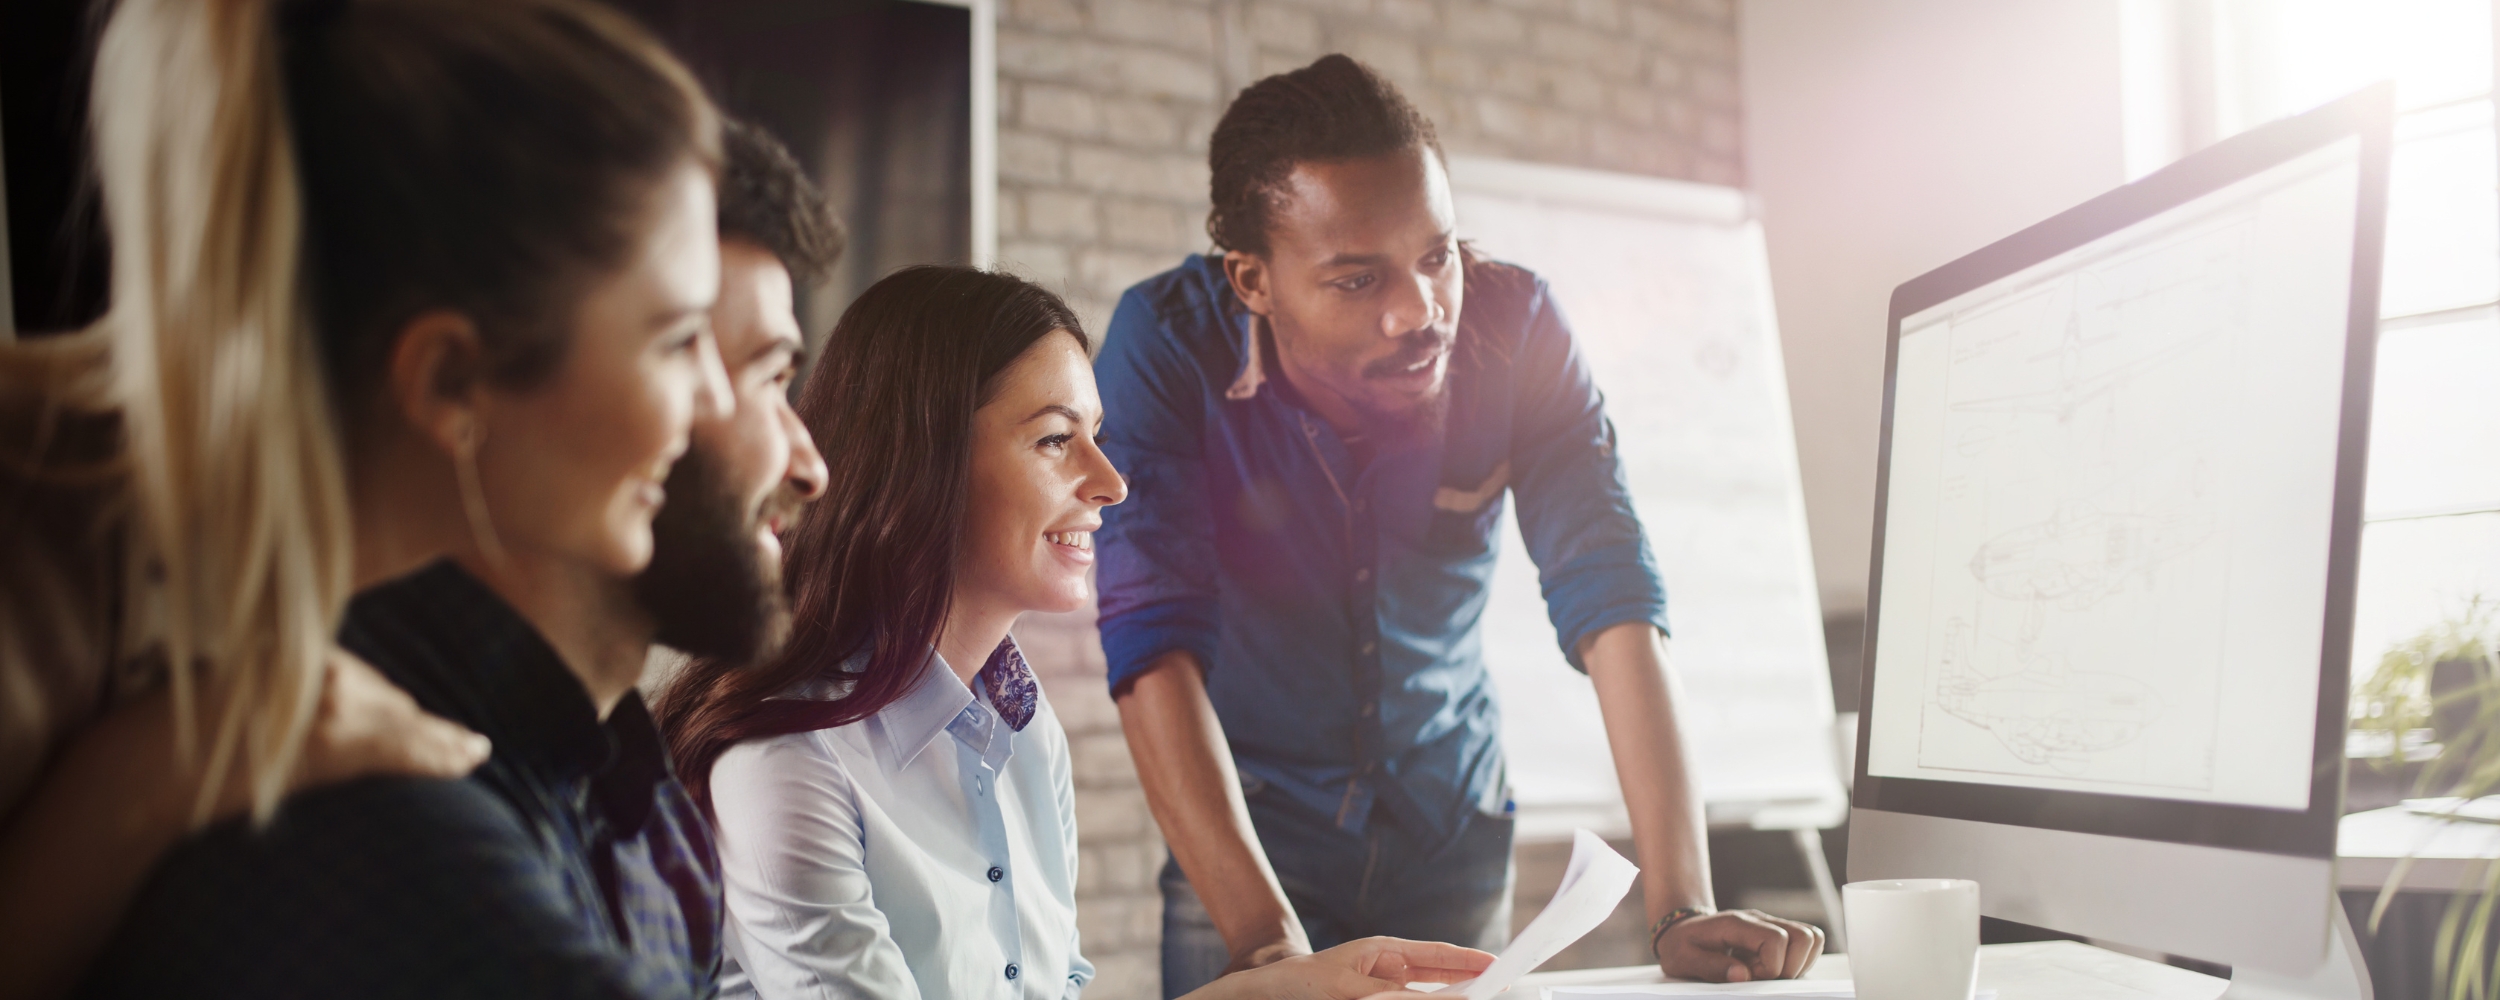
[1098,55,1823,995]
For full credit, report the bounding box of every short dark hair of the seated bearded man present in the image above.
[720,120,845,288]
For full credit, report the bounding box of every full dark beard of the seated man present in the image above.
[633,448,790,665]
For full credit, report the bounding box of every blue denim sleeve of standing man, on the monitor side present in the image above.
[1513,280,1668,670]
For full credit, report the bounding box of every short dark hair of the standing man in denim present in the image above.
[1208,55,1443,255]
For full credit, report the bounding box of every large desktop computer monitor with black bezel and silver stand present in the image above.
[1848,85,2393,978]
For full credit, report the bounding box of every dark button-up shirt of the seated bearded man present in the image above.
[83,563,720,998]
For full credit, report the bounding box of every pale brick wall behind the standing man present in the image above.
[998,0,1745,1000]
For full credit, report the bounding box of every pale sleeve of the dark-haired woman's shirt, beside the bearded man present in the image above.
[713,740,920,1000]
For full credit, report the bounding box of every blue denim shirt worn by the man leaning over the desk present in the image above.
[1095,253,1668,845]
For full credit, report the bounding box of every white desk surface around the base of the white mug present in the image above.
[1503,940,2230,1000]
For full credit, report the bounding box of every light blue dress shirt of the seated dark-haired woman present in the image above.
[713,655,1093,1000]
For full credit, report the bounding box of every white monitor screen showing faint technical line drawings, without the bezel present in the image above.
[1863,135,2363,810]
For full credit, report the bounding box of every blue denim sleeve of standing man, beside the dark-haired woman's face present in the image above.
[1095,290,1218,695]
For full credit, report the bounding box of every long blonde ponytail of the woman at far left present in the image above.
[90,0,355,823]
